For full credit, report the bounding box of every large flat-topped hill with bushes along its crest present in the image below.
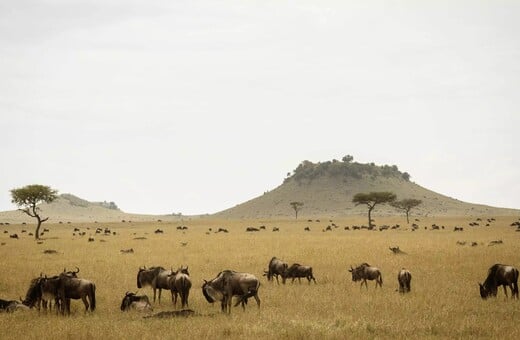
[215,159,520,218]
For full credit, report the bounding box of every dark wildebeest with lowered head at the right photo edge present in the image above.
[479,263,518,299]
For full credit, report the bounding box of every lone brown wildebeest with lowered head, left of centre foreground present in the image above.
[202,270,260,313]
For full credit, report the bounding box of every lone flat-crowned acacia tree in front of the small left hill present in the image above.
[11,184,58,239]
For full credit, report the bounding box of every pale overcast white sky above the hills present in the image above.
[0,0,520,214]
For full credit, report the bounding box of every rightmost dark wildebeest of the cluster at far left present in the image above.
[58,268,96,314]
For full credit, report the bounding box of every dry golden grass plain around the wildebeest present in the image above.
[0,216,520,339]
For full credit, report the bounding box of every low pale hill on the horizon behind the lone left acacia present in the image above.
[0,194,174,223]
